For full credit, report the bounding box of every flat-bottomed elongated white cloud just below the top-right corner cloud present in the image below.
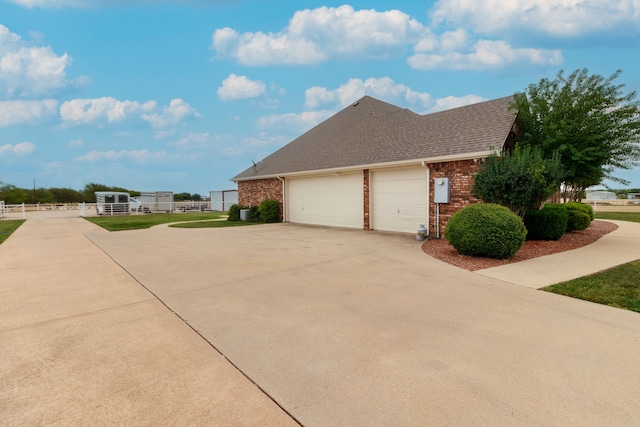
[407,40,562,70]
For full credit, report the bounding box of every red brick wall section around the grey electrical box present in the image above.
[429,160,480,236]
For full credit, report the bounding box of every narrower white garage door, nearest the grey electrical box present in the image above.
[371,167,428,233]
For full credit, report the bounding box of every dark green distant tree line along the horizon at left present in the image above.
[0,181,202,205]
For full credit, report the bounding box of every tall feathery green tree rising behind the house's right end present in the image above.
[514,68,640,200]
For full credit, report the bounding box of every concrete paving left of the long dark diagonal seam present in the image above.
[0,213,297,426]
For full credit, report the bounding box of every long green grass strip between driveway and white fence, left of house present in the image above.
[85,212,228,231]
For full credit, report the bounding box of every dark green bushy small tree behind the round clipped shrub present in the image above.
[471,146,563,217]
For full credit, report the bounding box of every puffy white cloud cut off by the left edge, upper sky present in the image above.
[0,24,88,97]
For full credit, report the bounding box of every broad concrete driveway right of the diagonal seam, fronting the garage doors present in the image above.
[78,220,640,426]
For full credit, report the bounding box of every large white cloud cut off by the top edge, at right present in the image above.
[431,0,640,37]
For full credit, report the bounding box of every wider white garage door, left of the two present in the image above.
[286,172,364,228]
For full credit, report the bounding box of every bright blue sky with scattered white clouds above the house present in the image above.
[0,0,640,195]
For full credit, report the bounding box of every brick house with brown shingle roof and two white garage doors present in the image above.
[232,96,516,234]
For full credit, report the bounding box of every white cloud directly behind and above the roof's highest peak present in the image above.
[305,77,431,108]
